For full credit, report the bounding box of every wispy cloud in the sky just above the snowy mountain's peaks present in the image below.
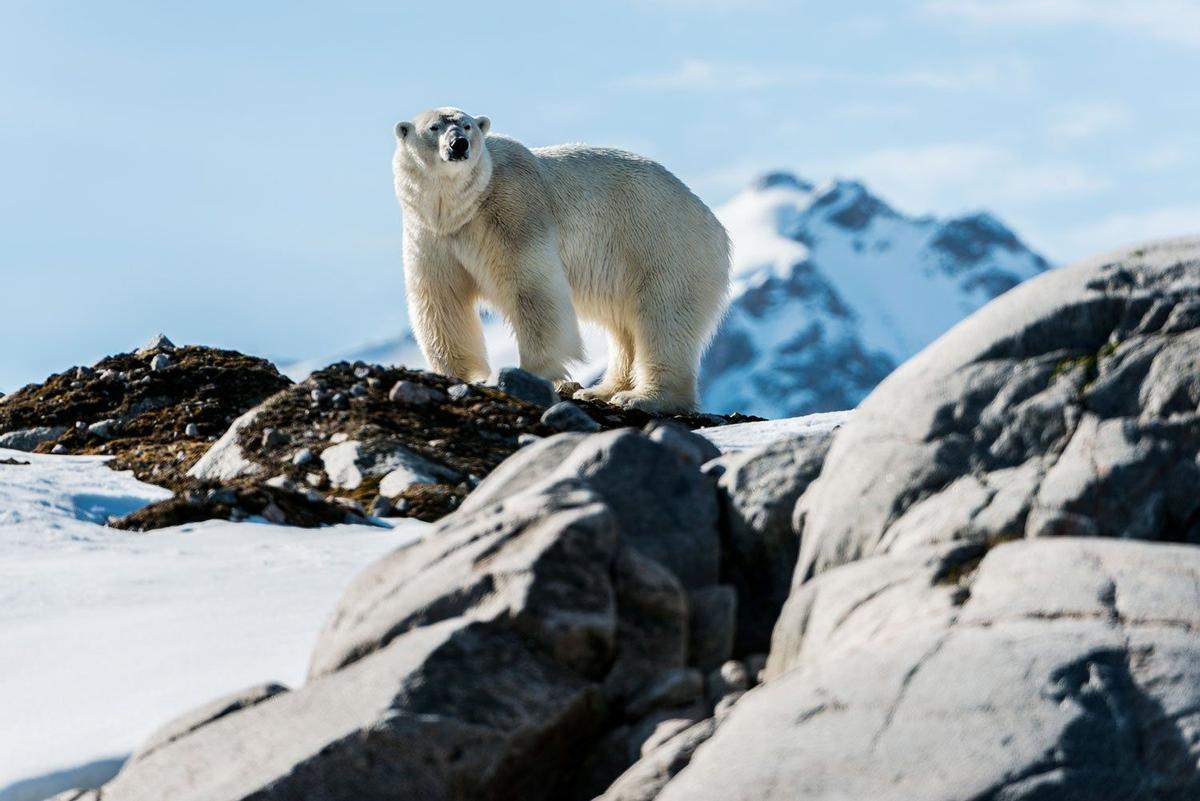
[832,141,1109,212]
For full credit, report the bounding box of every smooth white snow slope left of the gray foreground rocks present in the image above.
[0,450,426,801]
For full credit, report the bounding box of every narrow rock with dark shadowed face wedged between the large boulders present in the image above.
[714,432,833,654]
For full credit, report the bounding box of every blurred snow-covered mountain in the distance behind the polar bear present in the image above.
[284,173,1048,417]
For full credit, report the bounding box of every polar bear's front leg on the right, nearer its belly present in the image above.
[499,242,583,381]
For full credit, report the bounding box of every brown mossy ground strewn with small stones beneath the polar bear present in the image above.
[0,347,754,530]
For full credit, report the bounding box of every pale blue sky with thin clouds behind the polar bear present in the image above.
[0,0,1200,390]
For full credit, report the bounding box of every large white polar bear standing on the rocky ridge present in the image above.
[392,108,730,412]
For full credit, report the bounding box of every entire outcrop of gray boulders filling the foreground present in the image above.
[70,240,1200,801]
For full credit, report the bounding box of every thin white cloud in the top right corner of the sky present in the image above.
[922,0,1200,47]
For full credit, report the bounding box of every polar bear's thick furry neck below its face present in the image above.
[396,147,492,236]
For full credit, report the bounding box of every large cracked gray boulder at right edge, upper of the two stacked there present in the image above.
[797,239,1200,580]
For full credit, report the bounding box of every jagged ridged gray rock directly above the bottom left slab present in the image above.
[304,483,617,677]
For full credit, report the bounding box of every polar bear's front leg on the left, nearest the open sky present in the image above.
[404,244,490,381]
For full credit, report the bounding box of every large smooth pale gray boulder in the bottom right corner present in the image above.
[662,538,1200,801]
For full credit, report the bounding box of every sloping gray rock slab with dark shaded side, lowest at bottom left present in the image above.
[102,618,602,801]
